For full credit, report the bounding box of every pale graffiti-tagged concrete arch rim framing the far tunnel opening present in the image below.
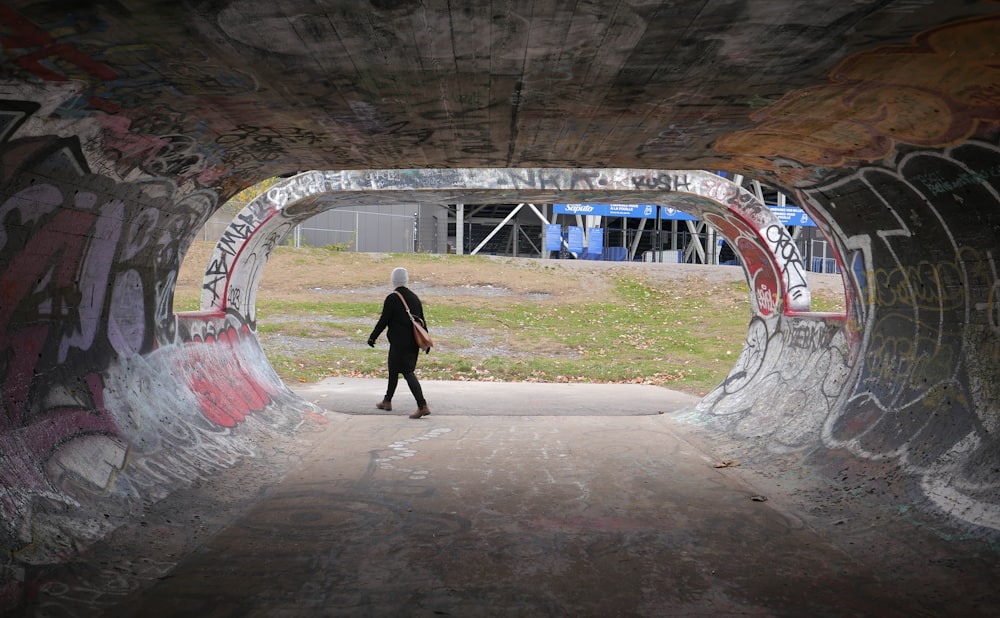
[184,169,846,400]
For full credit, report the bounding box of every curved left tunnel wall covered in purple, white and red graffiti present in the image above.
[0,84,320,610]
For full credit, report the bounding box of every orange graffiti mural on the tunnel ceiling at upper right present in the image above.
[716,17,1000,167]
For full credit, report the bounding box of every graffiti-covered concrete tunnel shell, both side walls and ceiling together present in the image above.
[0,0,1000,609]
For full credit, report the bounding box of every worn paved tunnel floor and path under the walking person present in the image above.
[17,378,1000,617]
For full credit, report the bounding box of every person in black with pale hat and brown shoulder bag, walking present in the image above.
[368,268,431,418]
